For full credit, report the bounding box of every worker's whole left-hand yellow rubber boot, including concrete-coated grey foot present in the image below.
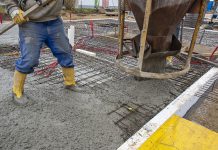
[13,71,29,106]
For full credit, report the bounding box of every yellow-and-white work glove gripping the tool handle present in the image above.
[11,9,29,24]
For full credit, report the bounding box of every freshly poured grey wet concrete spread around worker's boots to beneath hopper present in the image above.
[0,68,175,150]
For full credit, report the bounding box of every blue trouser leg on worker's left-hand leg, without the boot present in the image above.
[15,22,46,74]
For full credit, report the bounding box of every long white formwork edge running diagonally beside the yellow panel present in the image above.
[118,68,218,150]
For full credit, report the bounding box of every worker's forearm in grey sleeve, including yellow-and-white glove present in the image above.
[0,0,27,24]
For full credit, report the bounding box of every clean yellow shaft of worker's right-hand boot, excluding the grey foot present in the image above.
[62,68,76,86]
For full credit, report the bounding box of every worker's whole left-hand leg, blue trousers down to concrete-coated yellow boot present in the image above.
[13,23,45,104]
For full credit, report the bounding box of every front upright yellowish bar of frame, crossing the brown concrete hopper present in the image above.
[139,0,152,71]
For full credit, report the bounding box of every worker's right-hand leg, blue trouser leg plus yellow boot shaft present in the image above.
[46,19,76,90]
